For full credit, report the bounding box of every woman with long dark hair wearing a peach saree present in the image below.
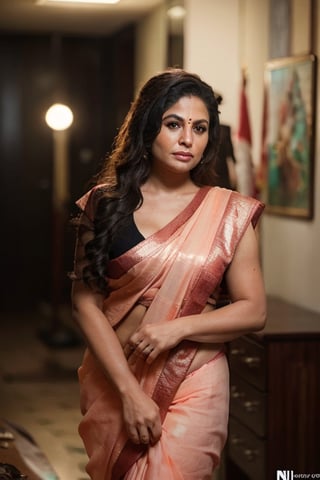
[72,69,266,480]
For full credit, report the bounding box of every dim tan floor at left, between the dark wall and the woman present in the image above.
[0,312,88,480]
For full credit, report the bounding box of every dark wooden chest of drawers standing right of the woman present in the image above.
[226,298,320,480]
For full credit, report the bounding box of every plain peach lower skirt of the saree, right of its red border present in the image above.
[124,348,229,480]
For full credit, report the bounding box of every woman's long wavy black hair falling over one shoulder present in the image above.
[82,69,221,295]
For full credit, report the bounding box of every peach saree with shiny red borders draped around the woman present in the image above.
[78,187,263,480]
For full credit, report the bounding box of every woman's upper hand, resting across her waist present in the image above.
[124,320,182,365]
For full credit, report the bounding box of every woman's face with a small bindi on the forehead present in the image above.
[151,96,209,173]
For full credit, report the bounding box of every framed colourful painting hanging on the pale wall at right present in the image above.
[266,54,316,219]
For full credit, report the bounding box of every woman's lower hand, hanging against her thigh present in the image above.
[121,385,162,445]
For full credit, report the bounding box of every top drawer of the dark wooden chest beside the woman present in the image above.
[229,337,267,391]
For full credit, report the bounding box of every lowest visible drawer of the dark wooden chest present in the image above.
[228,416,266,480]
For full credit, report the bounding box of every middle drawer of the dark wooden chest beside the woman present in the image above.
[230,371,267,437]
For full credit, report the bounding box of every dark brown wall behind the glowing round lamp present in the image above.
[0,27,134,311]
